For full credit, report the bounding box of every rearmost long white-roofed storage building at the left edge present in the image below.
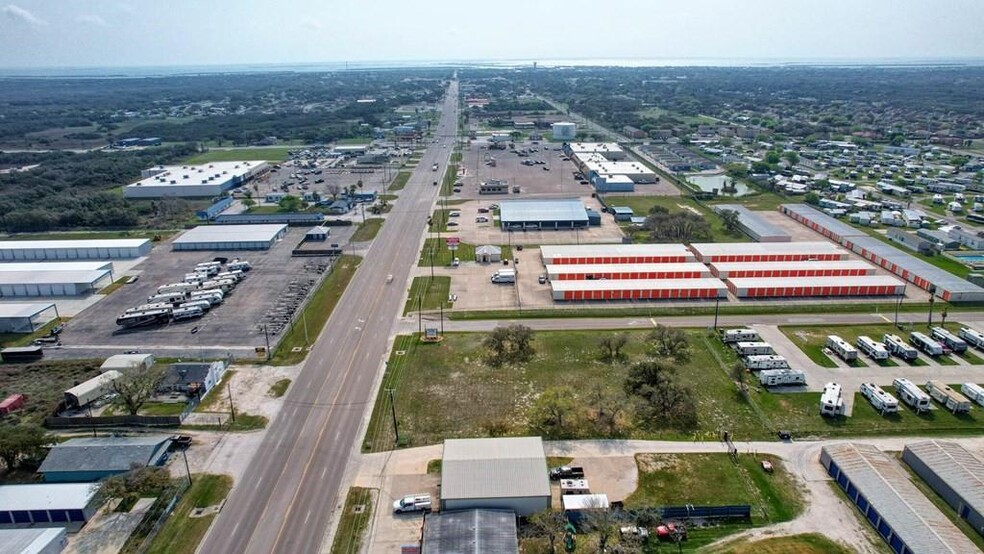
[0,239,152,262]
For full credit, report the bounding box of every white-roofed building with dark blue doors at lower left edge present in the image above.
[0,483,99,526]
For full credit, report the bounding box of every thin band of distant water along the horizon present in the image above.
[0,58,984,78]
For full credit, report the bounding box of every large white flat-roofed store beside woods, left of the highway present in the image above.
[123,161,270,198]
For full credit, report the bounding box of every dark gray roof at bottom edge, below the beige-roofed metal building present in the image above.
[423,510,519,554]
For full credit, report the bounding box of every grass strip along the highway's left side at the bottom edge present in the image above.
[147,474,232,554]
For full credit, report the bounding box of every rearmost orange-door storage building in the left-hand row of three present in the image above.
[540,244,697,265]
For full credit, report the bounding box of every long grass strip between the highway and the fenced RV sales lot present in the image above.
[270,255,362,365]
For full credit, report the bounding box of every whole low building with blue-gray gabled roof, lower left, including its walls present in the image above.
[38,435,171,483]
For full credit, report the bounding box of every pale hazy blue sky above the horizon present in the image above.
[0,0,984,68]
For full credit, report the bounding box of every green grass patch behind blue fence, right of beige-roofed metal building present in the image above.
[625,454,804,548]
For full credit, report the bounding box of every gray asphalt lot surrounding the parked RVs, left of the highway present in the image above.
[54,227,338,357]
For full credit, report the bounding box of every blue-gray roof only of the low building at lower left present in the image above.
[38,435,171,473]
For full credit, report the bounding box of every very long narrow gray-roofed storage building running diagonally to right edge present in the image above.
[779,204,984,302]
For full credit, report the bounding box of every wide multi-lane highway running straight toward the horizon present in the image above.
[198,82,458,554]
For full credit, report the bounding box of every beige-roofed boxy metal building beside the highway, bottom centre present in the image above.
[441,437,550,516]
